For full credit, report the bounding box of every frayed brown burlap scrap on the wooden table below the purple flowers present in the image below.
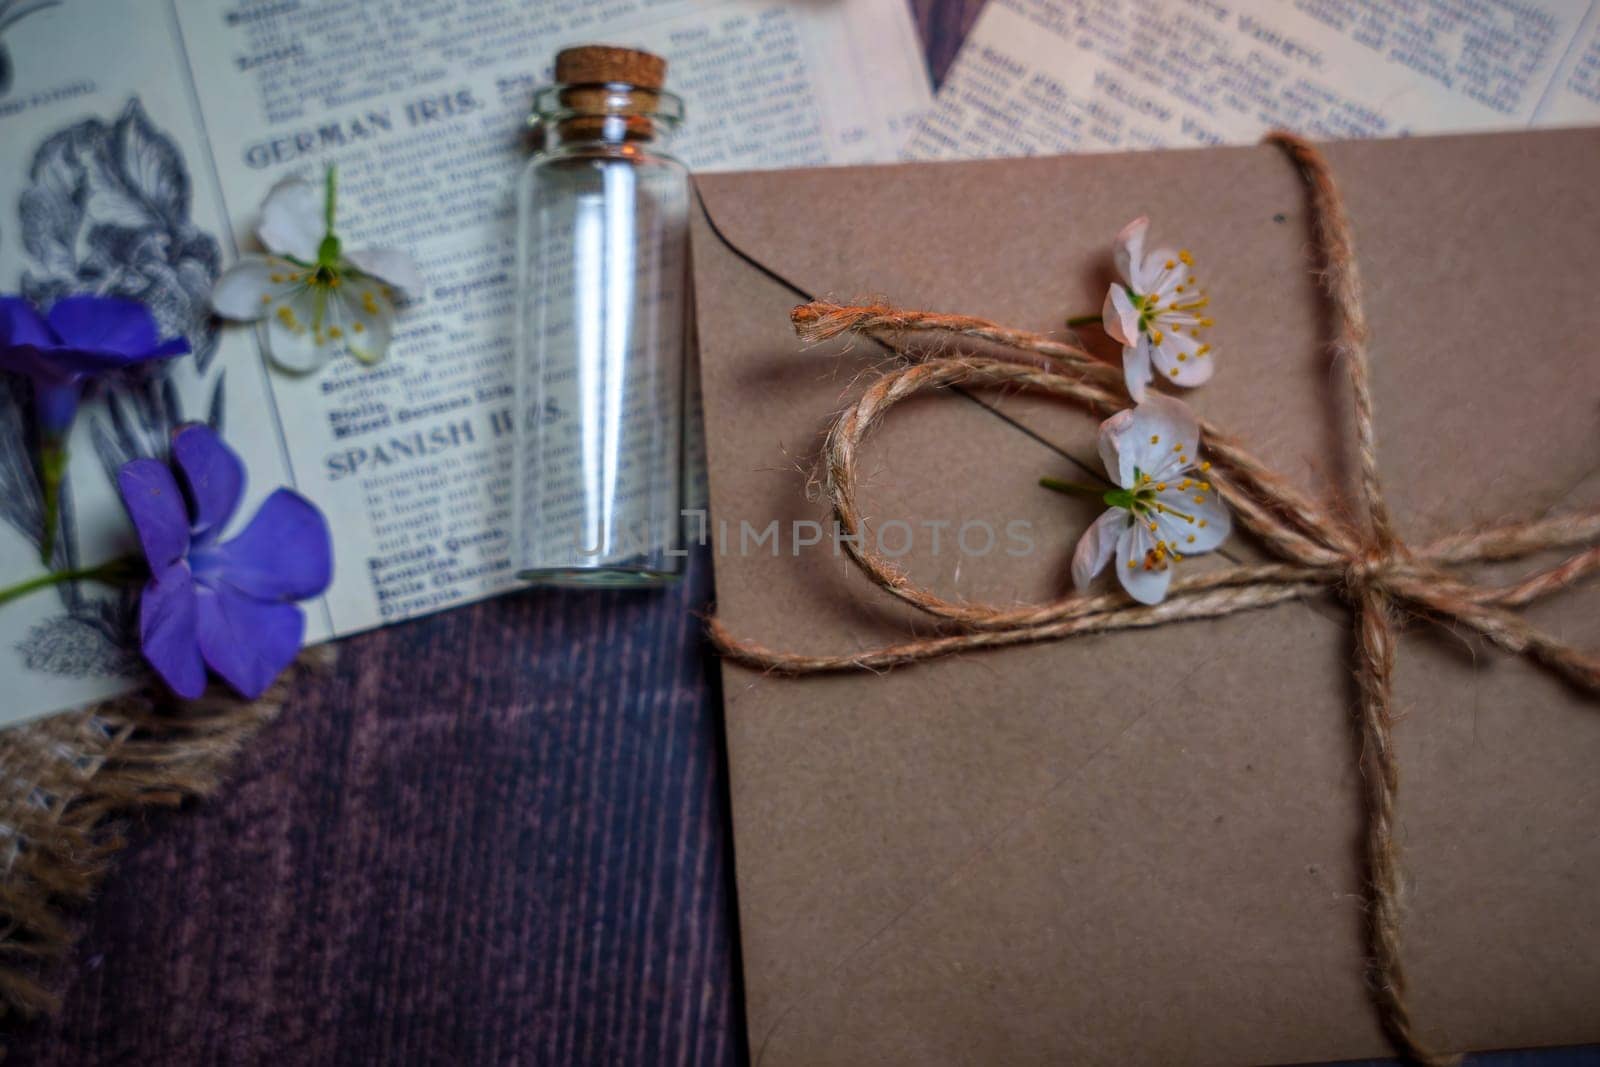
[0,645,333,1036]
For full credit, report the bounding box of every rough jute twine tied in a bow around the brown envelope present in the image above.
[707,133,1600,1064]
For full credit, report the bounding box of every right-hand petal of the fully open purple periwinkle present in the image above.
[203,490,333,600]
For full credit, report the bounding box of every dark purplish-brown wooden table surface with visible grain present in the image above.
[8,0,1595,1065]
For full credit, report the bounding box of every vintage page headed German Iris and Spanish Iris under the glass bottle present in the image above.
[0,0,930,723]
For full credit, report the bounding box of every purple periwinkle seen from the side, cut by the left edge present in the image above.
[0,294,189,438]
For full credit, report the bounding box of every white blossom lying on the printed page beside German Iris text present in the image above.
[211,170,422,374]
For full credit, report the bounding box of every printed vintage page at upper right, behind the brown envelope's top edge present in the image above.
[907,0,1600,160]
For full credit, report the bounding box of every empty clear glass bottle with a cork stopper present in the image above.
[512,46,690,587]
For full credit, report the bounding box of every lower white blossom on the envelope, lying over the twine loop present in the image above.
[1072,395,1234,605]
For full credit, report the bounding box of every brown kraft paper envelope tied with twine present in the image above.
[693,131,1600,1065]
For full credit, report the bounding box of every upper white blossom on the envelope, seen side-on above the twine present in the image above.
[1101,218,1214,402]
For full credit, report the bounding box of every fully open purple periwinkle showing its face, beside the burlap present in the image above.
[117,422,333,699]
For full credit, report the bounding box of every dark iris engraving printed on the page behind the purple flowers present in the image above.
[0,102,226,677]
